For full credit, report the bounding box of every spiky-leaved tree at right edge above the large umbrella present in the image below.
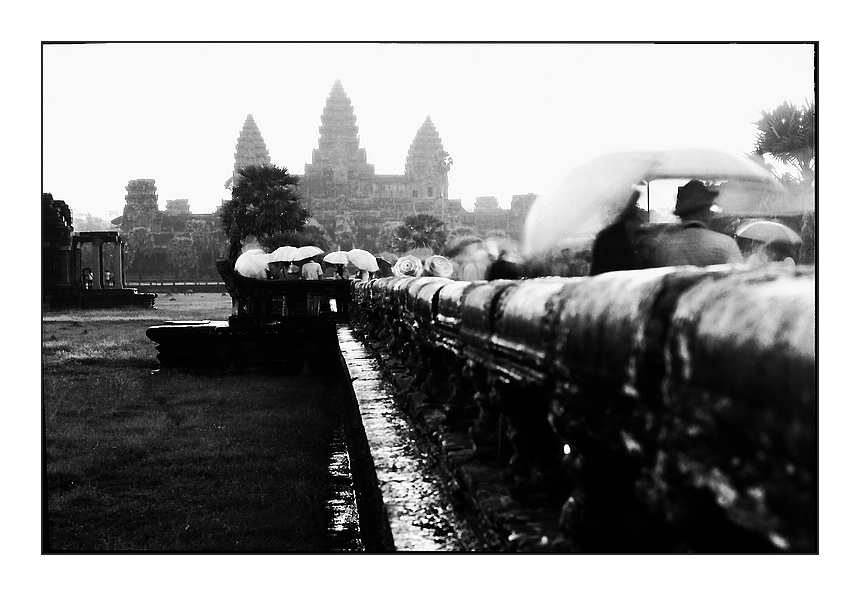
[755,101,815,186]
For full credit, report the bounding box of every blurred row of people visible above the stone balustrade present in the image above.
[232,180,797,290]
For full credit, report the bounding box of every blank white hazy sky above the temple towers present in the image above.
[43,43,814,215]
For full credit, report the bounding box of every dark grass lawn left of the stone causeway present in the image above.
[42,294,340,552]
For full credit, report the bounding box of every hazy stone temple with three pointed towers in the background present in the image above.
[115,80,535,251]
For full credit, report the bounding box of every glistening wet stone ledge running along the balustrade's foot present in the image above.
[338,327,481,551]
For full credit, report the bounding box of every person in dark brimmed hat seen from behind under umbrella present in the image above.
[653,180,744,267]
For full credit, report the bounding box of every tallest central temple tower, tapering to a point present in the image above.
[303,79,374,202]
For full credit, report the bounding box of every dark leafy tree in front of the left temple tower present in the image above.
[220,165,310,261]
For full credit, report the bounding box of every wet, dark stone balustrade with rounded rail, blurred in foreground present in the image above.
[351,266,818,552]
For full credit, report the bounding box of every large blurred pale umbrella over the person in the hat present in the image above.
[523,149,780,255]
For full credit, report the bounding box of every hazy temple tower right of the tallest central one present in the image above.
[406,116,452,204]
